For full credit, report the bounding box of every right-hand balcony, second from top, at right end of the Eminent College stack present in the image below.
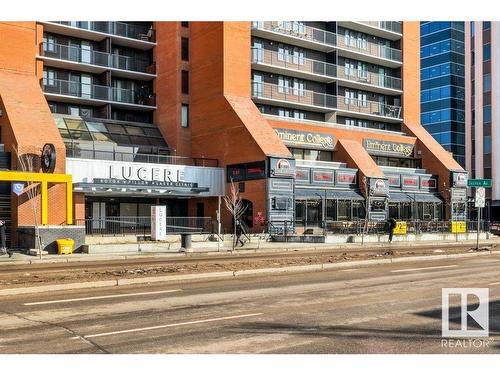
[337,35,402,68]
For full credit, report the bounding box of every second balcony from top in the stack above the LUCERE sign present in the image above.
[40,42,155,80]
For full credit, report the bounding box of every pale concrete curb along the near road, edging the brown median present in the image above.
[0,251,500,297]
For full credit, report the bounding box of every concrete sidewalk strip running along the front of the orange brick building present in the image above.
[0,236,500,267]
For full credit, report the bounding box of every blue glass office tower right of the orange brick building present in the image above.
[420,22,465,167]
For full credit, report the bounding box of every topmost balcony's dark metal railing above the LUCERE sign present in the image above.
[53,21,155,42]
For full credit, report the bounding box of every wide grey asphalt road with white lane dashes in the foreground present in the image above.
[0,255,500,353]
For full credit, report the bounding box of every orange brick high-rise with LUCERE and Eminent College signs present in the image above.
[0,21,467,253]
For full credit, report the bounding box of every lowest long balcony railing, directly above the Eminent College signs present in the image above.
[252,82,401,119]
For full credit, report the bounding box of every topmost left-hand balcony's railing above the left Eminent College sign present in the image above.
[252,21,337,46]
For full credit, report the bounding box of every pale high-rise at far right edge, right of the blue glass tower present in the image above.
[465,22,500,220]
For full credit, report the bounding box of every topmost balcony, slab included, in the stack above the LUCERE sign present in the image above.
[42,21,156,49]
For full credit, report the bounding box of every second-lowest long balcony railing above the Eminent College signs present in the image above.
[252,48,401,90]
